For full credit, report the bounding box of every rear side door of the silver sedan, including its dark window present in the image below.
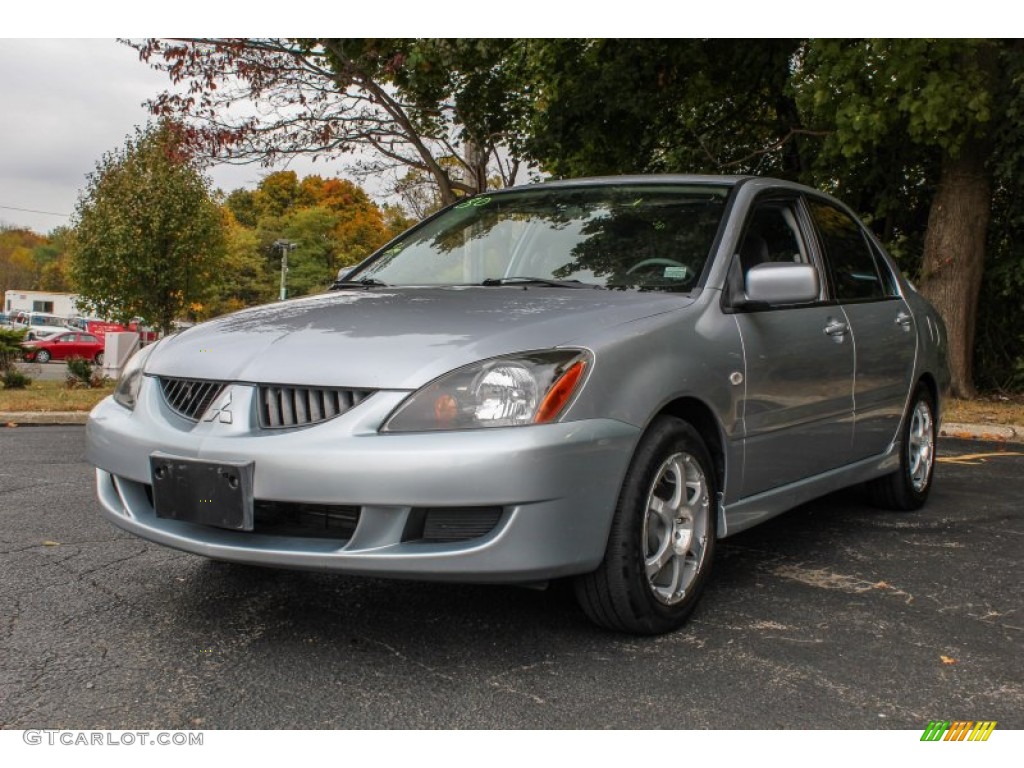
[807,198,918,460]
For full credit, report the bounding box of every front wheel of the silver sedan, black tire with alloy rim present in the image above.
[575,417,718,635]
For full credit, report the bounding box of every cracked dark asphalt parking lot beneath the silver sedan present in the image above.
[0,427,1024,730]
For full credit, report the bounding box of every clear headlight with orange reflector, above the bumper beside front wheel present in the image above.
[382,349,592,432]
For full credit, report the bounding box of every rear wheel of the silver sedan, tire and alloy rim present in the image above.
[866,384,937,512]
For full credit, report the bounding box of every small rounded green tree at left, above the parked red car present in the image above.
[72,121,224,331]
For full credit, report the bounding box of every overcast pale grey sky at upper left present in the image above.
[0,39,344,233]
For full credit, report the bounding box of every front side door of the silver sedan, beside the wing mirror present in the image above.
[730,196,854,497]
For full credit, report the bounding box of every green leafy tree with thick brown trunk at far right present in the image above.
[798,40,1024,397]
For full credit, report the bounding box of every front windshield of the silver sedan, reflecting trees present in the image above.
[347,185,729,291]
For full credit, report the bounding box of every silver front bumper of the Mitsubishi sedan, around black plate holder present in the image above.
[86,378,640,583]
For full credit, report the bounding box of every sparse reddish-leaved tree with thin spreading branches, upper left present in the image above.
[126,38,528,204]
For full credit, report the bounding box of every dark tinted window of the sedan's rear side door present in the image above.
[808,200,888,301]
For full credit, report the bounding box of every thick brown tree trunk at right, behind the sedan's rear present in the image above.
[921,139,992,397]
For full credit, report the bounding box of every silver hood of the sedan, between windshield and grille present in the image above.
[146,286,692,389]
